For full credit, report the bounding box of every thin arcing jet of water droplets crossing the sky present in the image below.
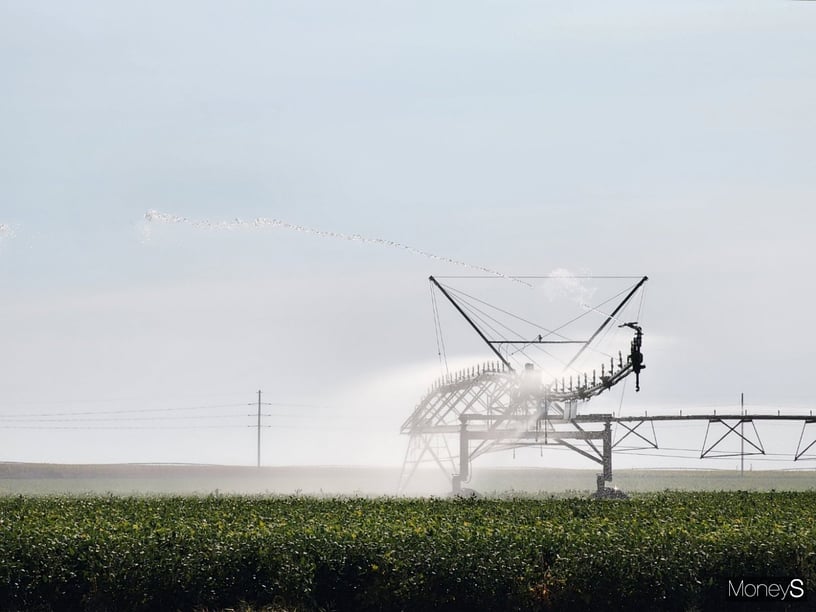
[144,210,529,285]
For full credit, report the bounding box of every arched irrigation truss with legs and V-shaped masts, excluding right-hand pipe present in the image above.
[400,277,647,491]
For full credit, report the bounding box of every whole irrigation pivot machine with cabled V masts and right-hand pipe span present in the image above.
[400,275,816,497]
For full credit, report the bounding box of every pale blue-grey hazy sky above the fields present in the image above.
[0,0,816,474]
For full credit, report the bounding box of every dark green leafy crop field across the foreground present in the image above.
[0,492,816,610]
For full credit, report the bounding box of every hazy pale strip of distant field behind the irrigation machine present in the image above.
[0,463,816,496]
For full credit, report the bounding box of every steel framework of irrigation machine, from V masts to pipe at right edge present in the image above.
[400,277,816,495]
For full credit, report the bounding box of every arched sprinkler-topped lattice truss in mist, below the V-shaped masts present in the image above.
[400,359,634,489]
